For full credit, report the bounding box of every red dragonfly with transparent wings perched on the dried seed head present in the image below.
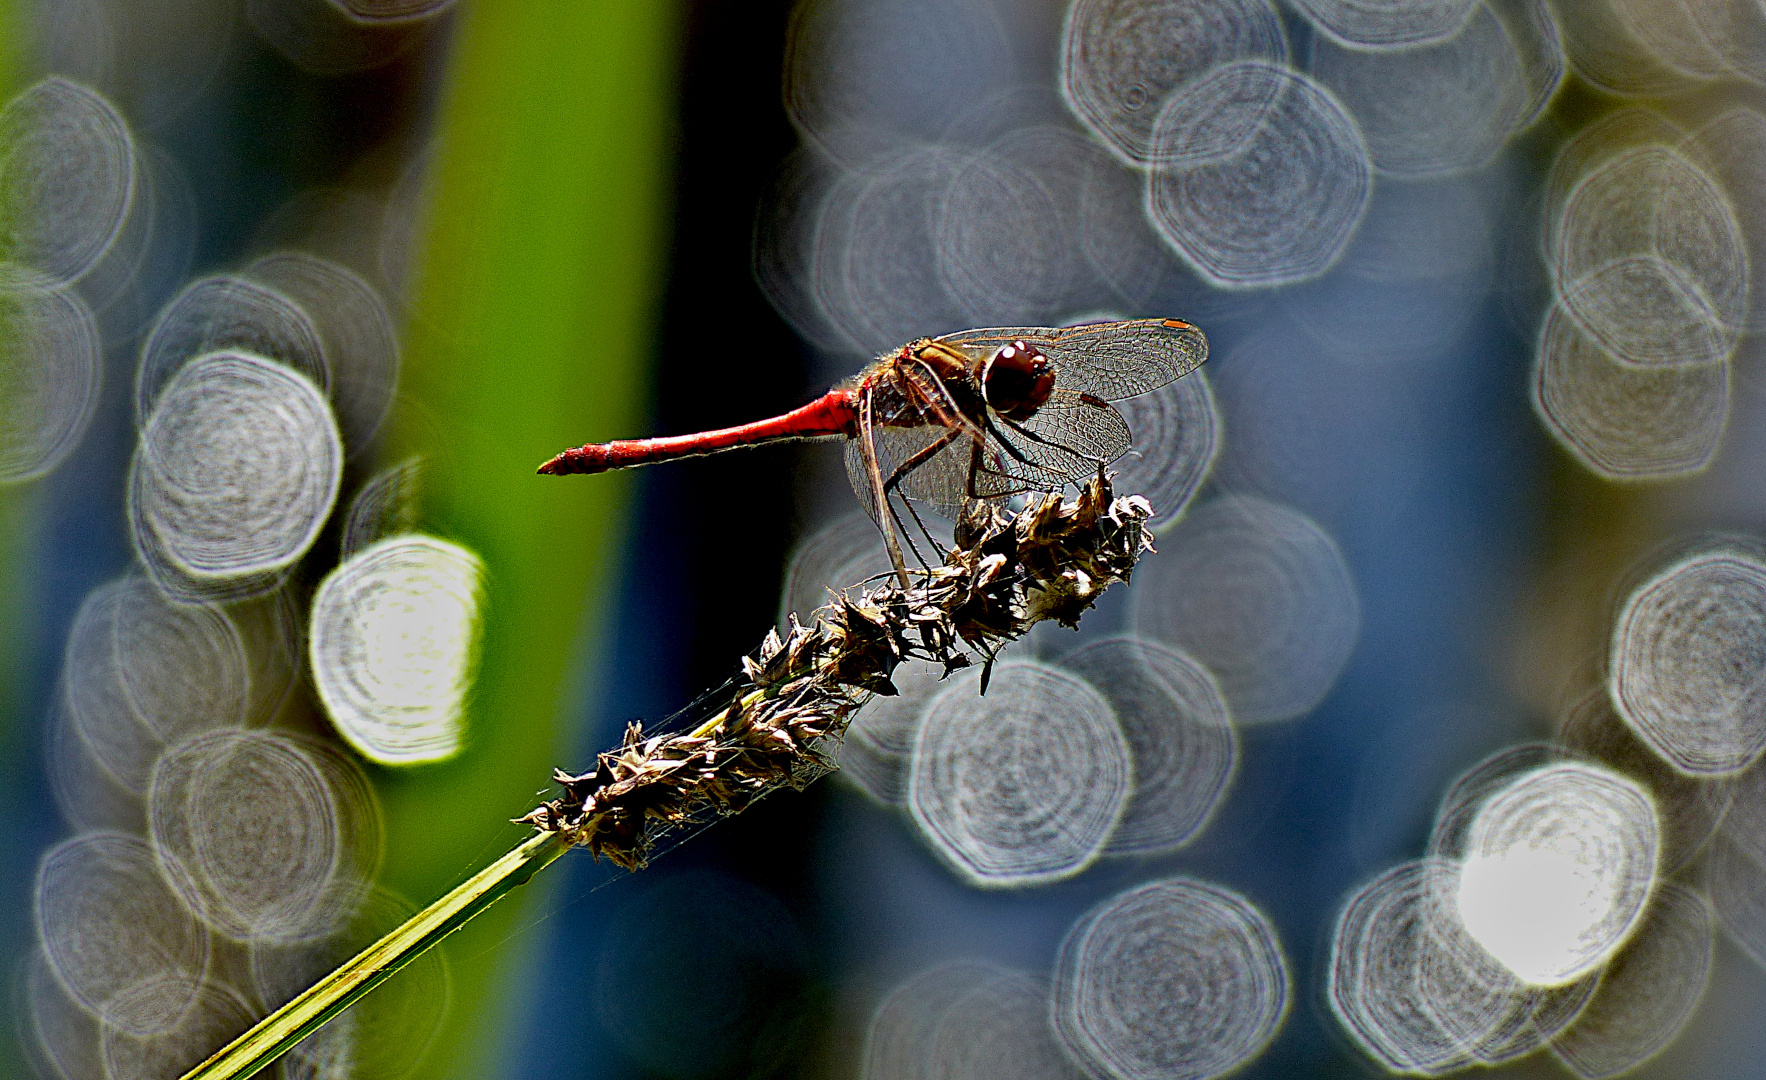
[539,319,1208,581]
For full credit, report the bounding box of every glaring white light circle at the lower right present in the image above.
[1457,762,1660,986]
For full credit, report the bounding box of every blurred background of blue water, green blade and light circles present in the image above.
[10,0,1766,1080]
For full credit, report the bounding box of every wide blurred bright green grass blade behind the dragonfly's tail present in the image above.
[376,0,682,1080]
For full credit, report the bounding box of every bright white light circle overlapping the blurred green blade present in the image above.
[311,535,484,764]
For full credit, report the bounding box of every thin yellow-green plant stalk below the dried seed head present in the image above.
[184,833,570,1080]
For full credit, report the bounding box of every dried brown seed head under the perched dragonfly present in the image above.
[519,473,1153,870]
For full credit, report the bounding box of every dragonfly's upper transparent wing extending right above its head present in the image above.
[938,319,1208,401]
